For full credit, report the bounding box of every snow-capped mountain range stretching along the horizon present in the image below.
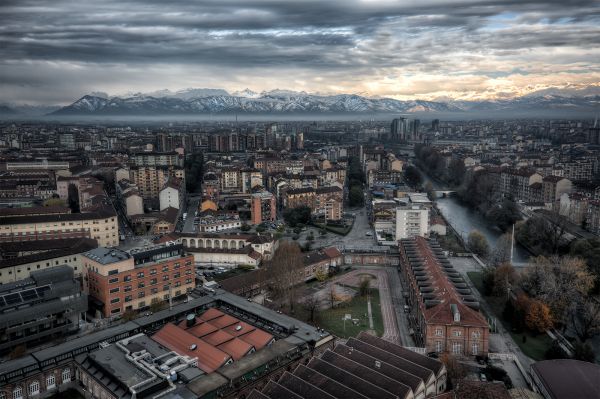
[0,86,600,117]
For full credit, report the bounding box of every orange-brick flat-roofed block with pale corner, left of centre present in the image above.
[83,243,196,317]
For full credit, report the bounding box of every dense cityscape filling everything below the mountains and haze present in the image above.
[0,117,600,398]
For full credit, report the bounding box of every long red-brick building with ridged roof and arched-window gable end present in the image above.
[399,237,489,356]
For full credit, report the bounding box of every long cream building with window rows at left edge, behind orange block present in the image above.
[0,207,119,247]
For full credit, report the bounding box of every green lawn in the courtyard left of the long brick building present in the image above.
[317,289,383,338]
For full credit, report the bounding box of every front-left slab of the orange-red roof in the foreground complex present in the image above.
[152,323,233,373]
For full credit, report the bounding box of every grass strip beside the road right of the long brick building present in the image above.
[467,272,552,360]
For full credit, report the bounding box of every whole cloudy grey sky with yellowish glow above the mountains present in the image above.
[0,0,600,104]
